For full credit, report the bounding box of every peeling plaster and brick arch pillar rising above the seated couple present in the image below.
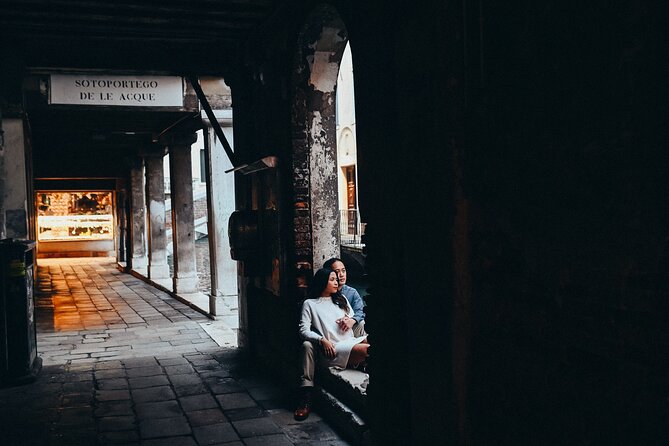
[293,8,347,274]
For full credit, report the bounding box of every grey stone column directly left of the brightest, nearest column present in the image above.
[166,133,198,294]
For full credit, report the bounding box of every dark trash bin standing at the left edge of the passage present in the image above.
[0,239,42,387]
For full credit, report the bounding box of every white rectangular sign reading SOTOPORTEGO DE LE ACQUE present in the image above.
[49,74,183,107]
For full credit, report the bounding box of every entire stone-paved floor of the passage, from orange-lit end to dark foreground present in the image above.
[0,259,348,446]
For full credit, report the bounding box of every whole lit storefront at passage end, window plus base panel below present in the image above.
[35,191,115,257]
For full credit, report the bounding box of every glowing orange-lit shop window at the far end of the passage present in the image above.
[36,191,114,241]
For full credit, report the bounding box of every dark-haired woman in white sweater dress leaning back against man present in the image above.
[295,269,369,421]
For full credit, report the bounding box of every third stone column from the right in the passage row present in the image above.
[144,147,171,287]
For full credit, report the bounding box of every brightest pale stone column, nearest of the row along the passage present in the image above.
[205,116,238,315]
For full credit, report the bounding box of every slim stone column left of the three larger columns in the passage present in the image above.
[129,158,149,275]
